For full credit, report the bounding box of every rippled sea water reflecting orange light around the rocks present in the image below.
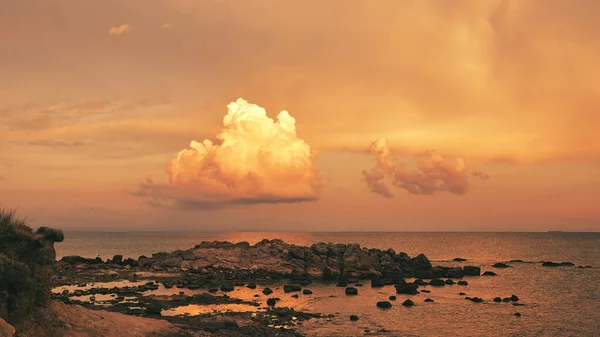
[56,232,600,336]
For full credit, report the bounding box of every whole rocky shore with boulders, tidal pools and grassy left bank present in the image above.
[0,210,589,336]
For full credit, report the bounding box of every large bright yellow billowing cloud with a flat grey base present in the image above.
[135,98,322,210]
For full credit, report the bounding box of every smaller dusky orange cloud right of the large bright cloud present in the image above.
[362,138,482,198]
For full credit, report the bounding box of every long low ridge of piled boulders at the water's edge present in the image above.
[79,239,444,280]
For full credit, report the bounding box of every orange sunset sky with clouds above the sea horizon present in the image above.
[0,0,600,231]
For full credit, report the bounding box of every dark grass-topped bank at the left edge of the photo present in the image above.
[0,210,64,330]
